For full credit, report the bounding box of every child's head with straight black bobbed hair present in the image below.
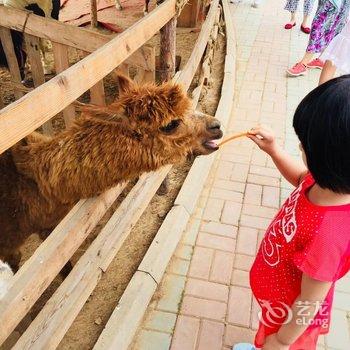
[293,75,350,193]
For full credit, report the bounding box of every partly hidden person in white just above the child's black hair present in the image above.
[319,18,350,85]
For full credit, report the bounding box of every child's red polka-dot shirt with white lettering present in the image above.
[250,175,350,350]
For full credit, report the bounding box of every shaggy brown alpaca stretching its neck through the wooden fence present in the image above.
[0,76,222,270]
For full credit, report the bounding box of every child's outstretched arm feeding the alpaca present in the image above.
[248,127,308,186]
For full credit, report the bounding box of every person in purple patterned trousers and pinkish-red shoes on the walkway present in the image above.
[287,0,350,77]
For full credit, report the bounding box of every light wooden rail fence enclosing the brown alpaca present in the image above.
[0,0,223,350]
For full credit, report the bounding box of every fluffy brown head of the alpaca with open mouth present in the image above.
[116,77,222,157]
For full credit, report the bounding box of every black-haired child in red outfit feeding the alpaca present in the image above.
[234,75,350,350]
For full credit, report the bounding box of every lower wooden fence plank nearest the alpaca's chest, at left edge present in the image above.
[0,186,124,345]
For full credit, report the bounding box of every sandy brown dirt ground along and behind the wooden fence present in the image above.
[0,19,225,350]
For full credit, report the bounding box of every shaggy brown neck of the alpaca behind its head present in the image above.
[17,119,166,203]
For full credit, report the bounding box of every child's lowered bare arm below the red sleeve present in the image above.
[263,273,332,350]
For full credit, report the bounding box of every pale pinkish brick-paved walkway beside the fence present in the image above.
[132,0,350,350]
